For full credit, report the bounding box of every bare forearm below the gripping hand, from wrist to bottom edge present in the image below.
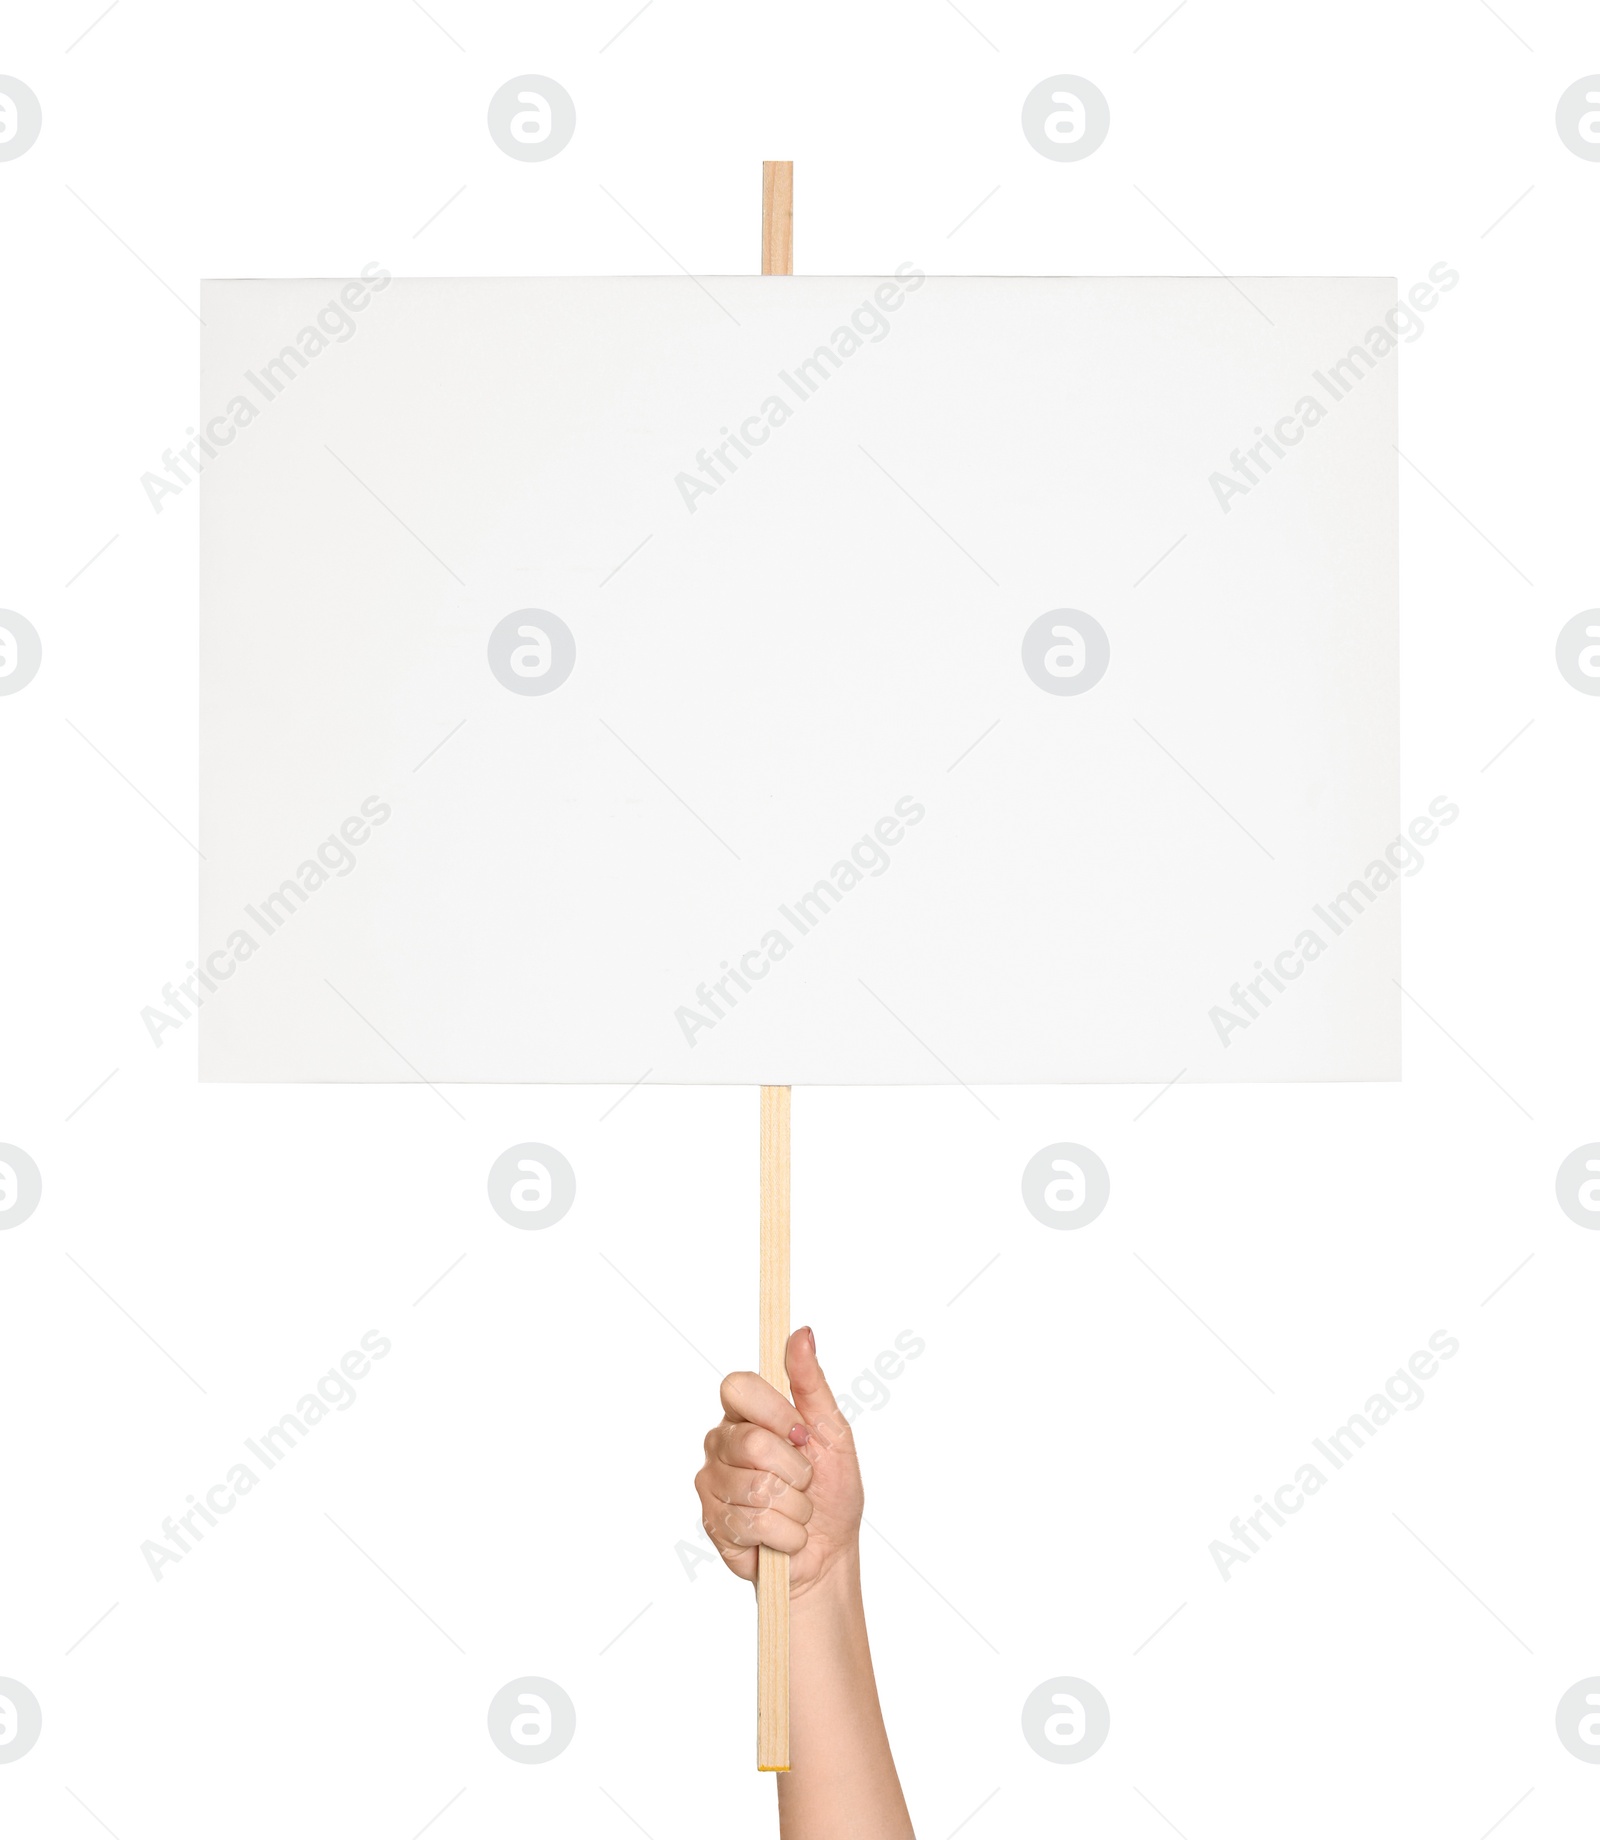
[778,1555,912,1840]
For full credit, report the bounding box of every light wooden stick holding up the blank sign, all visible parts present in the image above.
[756,160,794,1770]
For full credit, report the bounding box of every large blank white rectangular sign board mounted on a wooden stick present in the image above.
[200,269,1401,1086]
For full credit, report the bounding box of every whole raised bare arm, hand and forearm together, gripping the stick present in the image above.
[695,1328,914,1840]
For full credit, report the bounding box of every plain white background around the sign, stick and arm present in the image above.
[0,0,1600,1840]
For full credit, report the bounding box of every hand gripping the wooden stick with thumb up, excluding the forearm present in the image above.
[695,1328,863,1601]
